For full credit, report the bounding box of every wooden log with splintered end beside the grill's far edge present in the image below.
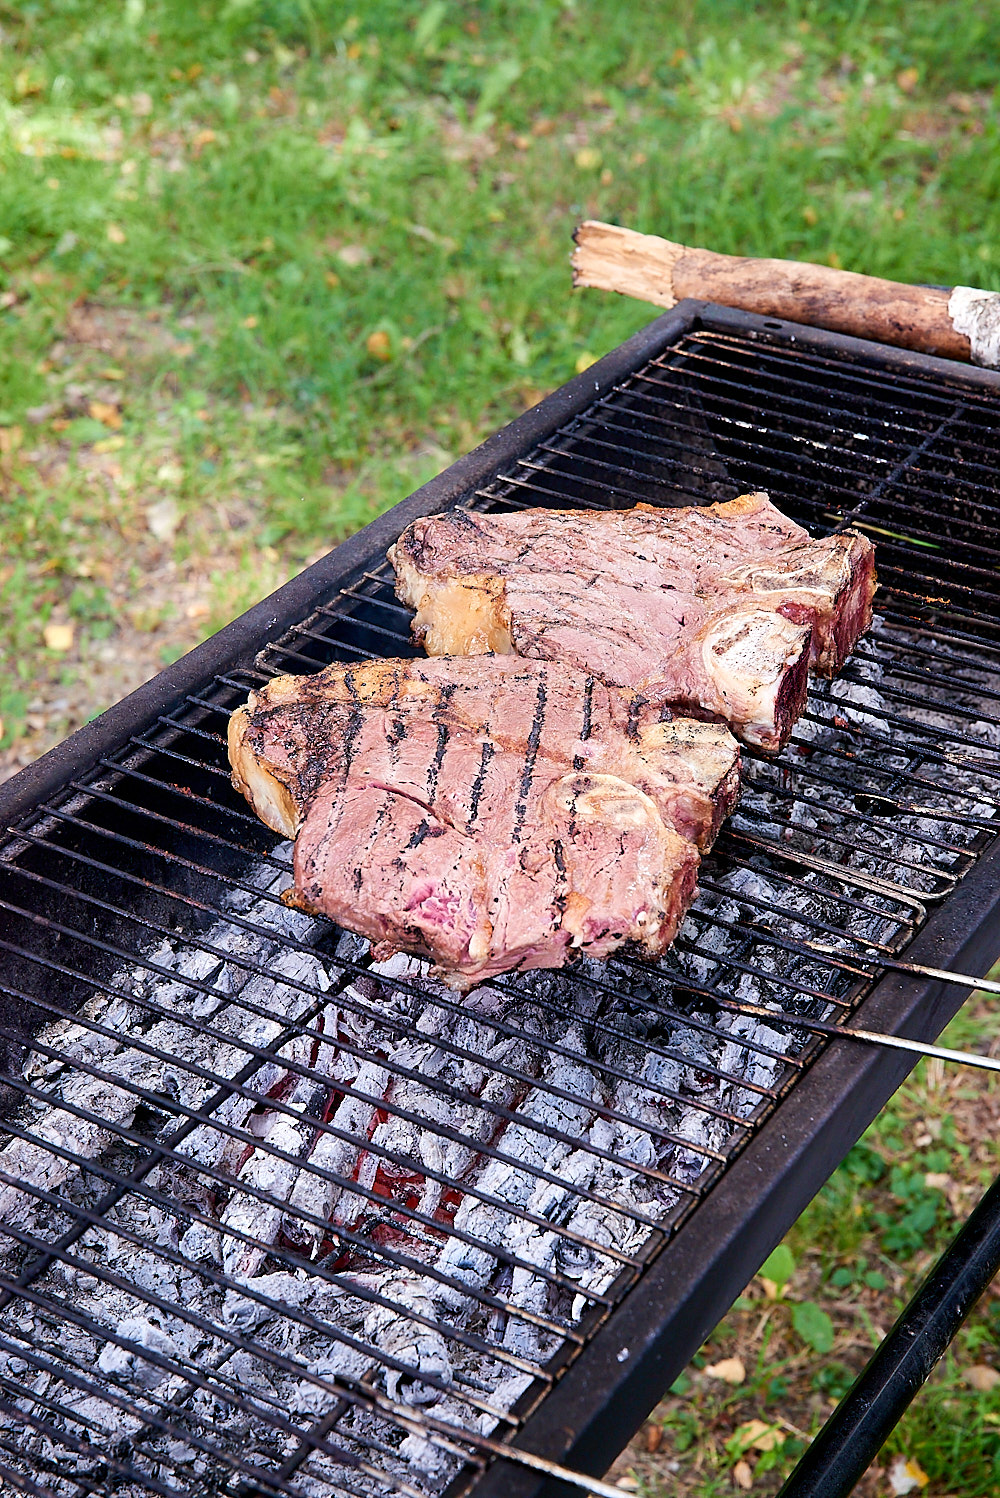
[573,219,1000,369]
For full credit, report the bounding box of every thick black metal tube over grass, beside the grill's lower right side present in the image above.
[778,1180,1000,1498]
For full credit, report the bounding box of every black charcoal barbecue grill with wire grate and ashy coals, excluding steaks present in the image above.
[0,303,1000,1498]
